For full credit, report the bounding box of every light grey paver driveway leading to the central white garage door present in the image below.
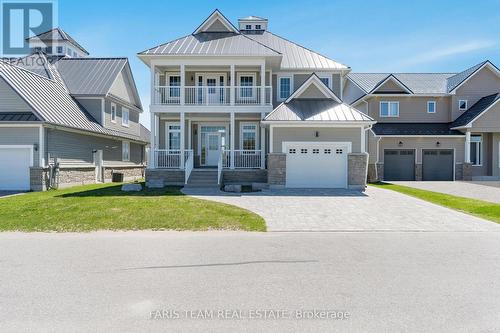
[184,187,500,231]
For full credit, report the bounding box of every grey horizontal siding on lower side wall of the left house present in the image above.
[47,129,141,165]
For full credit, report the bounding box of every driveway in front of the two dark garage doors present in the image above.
[391,182,500,204]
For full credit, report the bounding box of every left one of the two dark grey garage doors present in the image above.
[384,149,415,180]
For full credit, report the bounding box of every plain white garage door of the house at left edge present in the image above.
[0,146,31,191]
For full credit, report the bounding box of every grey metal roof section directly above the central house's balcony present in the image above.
[139,32,280,56]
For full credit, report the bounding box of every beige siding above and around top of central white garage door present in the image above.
[273,127,361,153]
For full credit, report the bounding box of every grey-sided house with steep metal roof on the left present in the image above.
[0,28,150,191]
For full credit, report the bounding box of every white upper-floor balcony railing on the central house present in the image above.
[154,86,272,106]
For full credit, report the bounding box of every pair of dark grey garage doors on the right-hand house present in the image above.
[384,149,455,181]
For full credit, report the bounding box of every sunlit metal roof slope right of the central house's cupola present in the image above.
[245,31,349,70]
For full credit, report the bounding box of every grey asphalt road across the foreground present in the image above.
[0,232,500,333]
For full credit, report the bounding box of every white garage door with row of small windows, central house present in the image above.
[283,142,351,188]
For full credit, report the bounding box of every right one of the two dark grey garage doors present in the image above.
[422,149,455,181]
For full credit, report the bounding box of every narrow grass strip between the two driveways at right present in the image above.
[370,183,500,223]
